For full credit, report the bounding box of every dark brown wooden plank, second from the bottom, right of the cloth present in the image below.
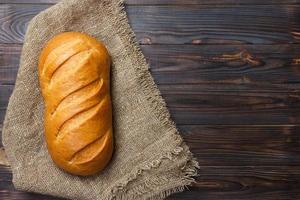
[0,125,300,167]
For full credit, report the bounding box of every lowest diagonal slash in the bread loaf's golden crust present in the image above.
[69,127,111,165]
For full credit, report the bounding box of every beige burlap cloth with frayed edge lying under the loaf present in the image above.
[2,0,198,200]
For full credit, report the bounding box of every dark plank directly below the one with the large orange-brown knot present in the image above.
[0,85,300,125]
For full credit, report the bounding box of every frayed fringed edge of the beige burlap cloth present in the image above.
[106,0,200,200]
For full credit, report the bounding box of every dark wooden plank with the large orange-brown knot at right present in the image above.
[0,44,300,87]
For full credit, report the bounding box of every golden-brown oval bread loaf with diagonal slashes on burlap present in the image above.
[38,32,113,176]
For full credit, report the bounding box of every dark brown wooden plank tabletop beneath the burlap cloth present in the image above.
[0,0,300,200]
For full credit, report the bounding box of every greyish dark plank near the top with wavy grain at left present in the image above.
[0,4,300,44]
